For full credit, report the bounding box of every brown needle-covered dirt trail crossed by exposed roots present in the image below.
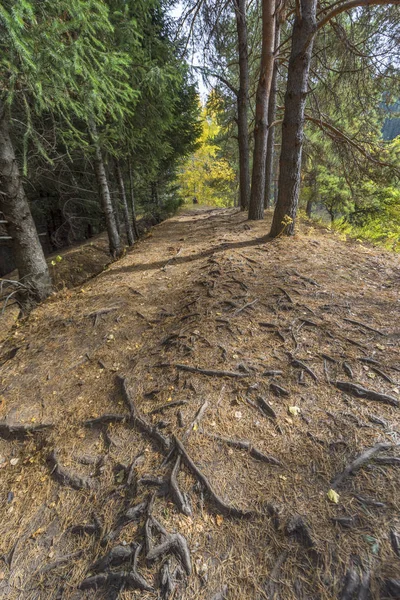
[0,209,400,600]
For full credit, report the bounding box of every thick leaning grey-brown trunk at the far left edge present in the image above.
[0,101,52,310]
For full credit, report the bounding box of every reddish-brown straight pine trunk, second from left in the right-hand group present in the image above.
[249,0,275,221]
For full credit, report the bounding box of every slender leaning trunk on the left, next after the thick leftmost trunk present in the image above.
[89,121,121,258]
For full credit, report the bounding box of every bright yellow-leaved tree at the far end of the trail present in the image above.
[177,108,237,206]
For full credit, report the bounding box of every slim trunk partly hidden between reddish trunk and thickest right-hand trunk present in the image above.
[264,19,281,208]
